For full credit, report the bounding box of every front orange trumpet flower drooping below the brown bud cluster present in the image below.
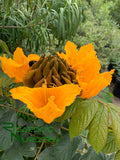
[10,84,81,123]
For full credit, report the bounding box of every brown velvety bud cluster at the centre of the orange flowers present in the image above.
[23,55,77,88]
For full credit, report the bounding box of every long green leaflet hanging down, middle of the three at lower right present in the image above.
[89,104,109,152]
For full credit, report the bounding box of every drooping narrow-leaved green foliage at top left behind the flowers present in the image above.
[0,0,85,52]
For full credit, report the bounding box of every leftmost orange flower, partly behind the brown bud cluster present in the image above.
[0,47,40,82]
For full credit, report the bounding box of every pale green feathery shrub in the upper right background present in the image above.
[73,2,120,70]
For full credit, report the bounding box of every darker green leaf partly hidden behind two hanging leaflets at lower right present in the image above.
[102,132,118,154]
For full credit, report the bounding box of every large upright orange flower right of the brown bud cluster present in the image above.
[57,41,114,98]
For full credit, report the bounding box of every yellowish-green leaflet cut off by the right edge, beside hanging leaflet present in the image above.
[110,109,120,148]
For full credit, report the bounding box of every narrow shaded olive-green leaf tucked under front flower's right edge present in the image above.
[56,98,81,122]
